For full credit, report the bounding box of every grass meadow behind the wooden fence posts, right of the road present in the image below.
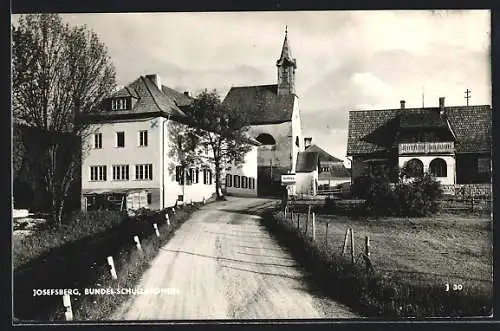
[288,214,493,300]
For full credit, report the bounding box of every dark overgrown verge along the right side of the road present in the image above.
[263,212,493,318]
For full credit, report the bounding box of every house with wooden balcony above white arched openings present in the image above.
[347,97,491,195]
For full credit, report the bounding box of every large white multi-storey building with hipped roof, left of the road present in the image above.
[81,74,256,209]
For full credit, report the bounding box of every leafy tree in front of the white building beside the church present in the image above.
[184,90,251,199]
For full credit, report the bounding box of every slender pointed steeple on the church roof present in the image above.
[276,28,297,96]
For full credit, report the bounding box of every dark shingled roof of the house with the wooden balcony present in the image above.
[347,105,491,155]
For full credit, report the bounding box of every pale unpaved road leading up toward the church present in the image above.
[112,197,356,320]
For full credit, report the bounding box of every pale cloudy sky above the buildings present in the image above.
[9,10,491,166]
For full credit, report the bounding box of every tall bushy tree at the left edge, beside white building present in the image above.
[12,14,115,224]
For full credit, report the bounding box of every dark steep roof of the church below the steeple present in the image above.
[223,84,295,125]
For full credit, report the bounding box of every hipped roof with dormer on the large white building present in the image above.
[86,76,186,119]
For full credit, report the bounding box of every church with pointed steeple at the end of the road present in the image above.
[223,32,304,195]
